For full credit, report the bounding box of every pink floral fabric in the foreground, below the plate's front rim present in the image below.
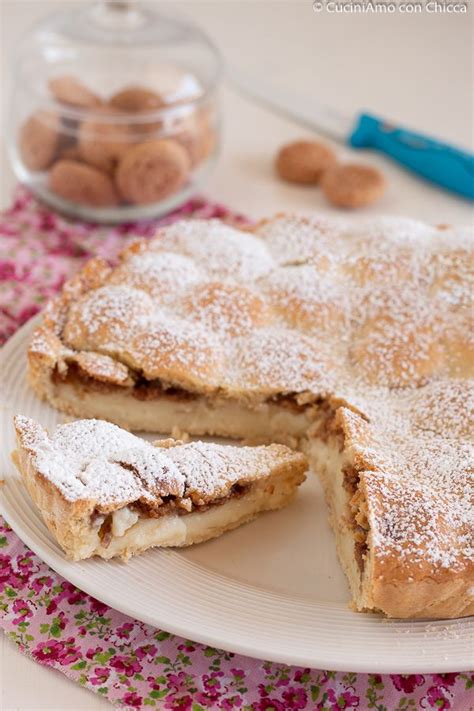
[0,517,474,711]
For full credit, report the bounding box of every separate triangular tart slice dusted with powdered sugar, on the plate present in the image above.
[13,416,307,560]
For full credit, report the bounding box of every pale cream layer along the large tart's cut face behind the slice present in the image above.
[42,380,317,446]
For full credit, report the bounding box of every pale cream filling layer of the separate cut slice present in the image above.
[74,474,300,560]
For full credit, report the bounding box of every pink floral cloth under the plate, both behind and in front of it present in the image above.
[0,189,474,711]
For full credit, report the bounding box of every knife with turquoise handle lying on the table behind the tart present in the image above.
[227,68,474,200]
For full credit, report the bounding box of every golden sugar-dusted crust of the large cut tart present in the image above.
[29,216,474,617]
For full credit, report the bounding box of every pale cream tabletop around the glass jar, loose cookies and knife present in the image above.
[0,0,474,711]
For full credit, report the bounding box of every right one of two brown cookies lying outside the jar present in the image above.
[321,163,385,208]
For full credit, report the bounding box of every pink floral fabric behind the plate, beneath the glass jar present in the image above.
[0,188,248,344]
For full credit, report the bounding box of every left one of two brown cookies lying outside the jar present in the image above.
[275,141,336,185]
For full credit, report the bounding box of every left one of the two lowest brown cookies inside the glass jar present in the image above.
[48,160,118,207]
